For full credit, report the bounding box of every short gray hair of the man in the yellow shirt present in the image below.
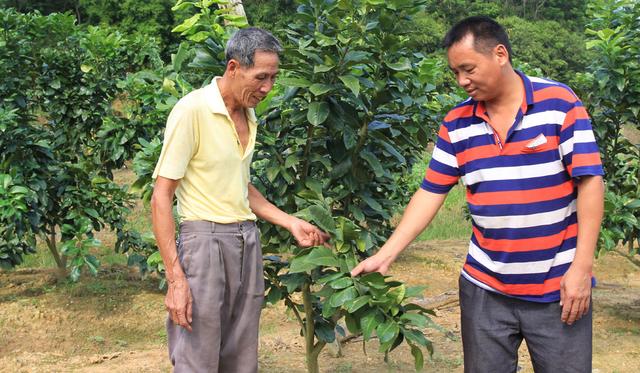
[224,27,282,67]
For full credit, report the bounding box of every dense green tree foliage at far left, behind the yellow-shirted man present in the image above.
[0,9,159,278]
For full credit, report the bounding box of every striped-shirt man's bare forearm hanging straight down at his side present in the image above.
[572,176,604,272]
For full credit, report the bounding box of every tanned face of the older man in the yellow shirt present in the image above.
[232,51,280,108]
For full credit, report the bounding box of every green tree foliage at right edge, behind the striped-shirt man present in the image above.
[582,0,640,254]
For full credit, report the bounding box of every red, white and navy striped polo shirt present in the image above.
[421,71,603,302]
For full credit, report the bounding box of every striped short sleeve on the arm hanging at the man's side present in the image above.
[559,98,604,178]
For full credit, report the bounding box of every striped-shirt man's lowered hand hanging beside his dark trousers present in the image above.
[560,266,591,325]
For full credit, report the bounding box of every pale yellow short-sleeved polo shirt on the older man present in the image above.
[153,77,257,223]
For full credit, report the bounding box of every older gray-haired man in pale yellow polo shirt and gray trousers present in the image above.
[151,28,328,373]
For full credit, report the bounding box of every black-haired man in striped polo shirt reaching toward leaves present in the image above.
[352,17,604,372]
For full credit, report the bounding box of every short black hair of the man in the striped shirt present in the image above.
[442,16,513,62]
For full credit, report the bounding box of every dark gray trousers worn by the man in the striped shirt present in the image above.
[460,276,592,373]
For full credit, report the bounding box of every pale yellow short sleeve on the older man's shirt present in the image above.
[153,103,198,180]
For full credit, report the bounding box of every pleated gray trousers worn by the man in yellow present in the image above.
[167,221,264,373]
